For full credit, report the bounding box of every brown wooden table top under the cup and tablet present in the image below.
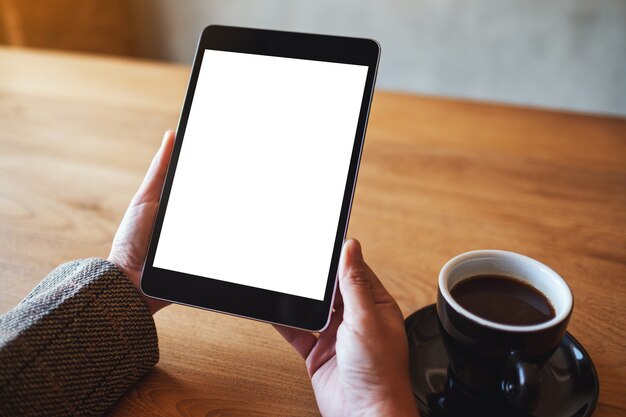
[0,48,626,416]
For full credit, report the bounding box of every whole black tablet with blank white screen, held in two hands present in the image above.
[141,26,380,331]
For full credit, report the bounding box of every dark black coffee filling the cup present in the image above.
[450,274,556,326]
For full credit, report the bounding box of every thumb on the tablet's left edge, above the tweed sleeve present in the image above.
[133,130,175,203]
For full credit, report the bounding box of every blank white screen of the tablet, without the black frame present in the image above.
[153,50,367,300]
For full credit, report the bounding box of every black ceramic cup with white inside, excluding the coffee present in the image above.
[437,250,574,411]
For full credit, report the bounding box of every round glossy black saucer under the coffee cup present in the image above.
[404,304,599,417]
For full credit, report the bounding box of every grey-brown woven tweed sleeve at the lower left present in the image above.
[0,259,159,416]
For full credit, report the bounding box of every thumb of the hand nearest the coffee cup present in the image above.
[338,239,375,321]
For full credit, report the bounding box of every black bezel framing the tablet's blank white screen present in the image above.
[141,25,380,331]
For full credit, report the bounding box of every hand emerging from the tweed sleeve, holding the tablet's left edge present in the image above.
[107,130,175,314]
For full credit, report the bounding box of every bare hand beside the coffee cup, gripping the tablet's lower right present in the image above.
[276,240,418,417]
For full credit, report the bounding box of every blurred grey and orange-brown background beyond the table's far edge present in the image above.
[0,0,626,115]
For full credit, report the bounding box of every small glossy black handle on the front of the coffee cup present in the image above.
[500,352,539,411]
